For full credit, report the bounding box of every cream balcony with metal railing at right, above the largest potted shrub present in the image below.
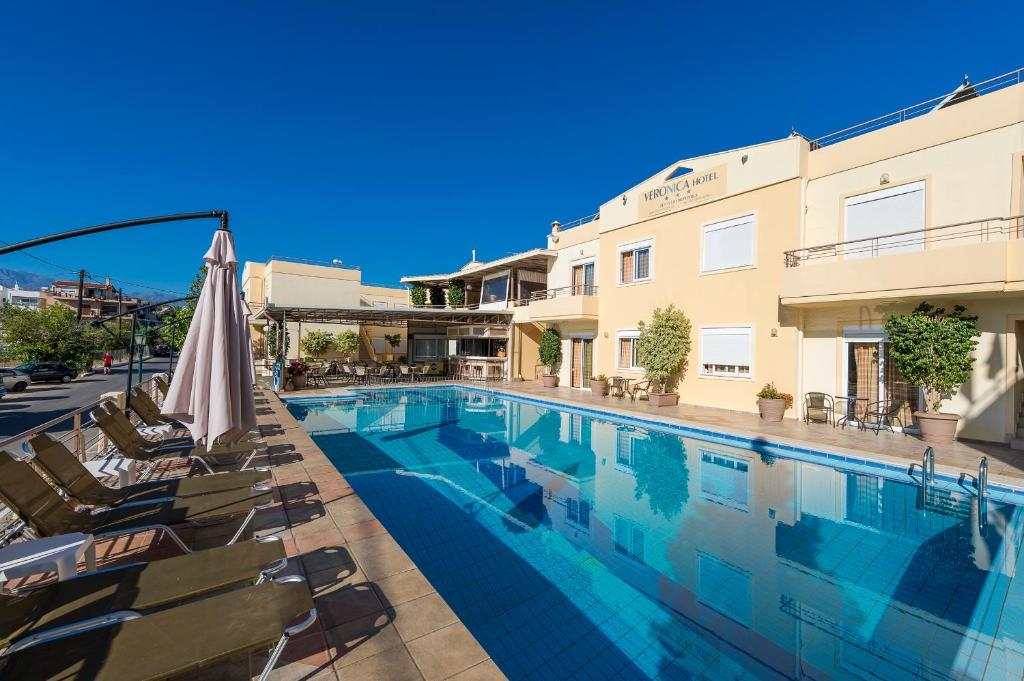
[779,215,1024,305]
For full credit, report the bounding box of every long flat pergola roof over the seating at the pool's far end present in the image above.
[253,304,512,327]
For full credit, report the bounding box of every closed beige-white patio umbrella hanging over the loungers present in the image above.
[162,229,256,451]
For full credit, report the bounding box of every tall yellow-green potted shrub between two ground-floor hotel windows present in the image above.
[637,305,690,407]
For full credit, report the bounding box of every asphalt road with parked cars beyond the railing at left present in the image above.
[0,357,169,439]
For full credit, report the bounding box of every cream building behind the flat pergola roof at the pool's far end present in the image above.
[242,257,409,359]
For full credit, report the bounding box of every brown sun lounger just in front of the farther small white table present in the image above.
[29,433,271,506]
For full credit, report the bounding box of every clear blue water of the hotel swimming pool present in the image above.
[289,388,1024,679]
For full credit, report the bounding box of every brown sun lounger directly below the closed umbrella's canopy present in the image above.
[91,402,266,473]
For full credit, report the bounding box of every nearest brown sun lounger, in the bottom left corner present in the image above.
[0,576,316,681]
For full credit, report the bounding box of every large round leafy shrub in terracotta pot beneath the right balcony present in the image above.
[886,302,981,444]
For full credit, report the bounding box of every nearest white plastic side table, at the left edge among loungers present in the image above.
[0,533,96,582]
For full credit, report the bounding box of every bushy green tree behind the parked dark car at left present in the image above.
[0,304,105,369]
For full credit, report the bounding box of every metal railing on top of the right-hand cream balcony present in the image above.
[783,215,1024,267]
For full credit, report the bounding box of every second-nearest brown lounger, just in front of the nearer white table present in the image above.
[0,536,288,649]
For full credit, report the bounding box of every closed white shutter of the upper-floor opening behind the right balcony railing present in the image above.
[843,181,925,259]
